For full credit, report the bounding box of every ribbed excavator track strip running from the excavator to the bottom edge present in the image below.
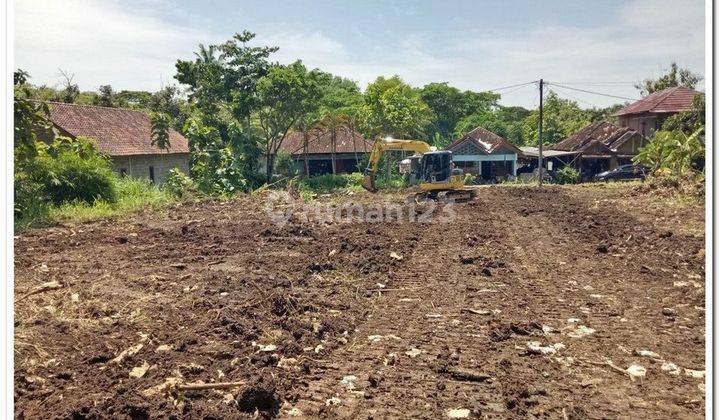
[298,199,506,417]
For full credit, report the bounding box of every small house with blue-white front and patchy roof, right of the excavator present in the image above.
[447,127,522,182]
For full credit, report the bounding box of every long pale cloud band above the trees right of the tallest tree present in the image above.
[242,0,705,107]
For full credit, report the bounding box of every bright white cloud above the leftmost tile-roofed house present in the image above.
[15,0,212,89]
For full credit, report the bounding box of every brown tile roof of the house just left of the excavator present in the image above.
[280,127,373,155]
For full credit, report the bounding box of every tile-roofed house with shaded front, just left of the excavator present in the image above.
[280,127,373,176]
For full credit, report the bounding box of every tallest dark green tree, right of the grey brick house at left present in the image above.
[175,31,277,193]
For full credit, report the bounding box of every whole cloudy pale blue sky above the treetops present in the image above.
[15,0,705,107]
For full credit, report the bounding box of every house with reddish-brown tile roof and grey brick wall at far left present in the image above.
[43,102,190,184]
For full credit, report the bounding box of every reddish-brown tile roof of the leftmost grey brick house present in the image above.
[48,102,190,156]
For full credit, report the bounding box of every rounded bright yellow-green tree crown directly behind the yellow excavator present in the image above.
[361,76,432,138]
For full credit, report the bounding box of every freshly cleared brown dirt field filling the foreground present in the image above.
[15,185,705,418]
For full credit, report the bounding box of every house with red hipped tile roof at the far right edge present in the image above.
[613,86,702,137]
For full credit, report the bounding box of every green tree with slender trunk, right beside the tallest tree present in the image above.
[253,61,322,182]
